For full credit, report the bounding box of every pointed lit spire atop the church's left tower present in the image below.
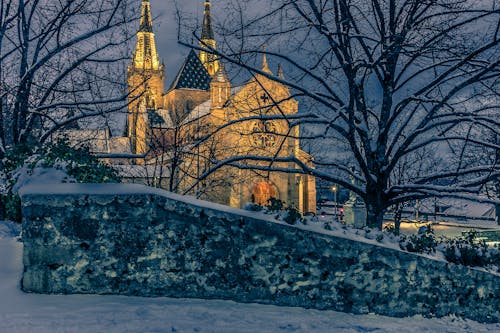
[133,0,161,70]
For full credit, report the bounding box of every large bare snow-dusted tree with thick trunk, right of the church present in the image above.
[181,0,500,227]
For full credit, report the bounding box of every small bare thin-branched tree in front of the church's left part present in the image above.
[135,99,229,201]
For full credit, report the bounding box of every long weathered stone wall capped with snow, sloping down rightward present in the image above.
[17,184,500,322]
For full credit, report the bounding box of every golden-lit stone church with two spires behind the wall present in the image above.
[106,0,316,213]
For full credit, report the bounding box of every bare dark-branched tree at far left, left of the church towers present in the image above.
[0,0,137,157]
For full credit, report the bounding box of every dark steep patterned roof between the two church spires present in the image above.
[169,50,211,91]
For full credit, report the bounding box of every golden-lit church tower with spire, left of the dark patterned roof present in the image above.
[127,0,165,154]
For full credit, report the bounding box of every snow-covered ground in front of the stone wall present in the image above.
[0,222,500,333]
